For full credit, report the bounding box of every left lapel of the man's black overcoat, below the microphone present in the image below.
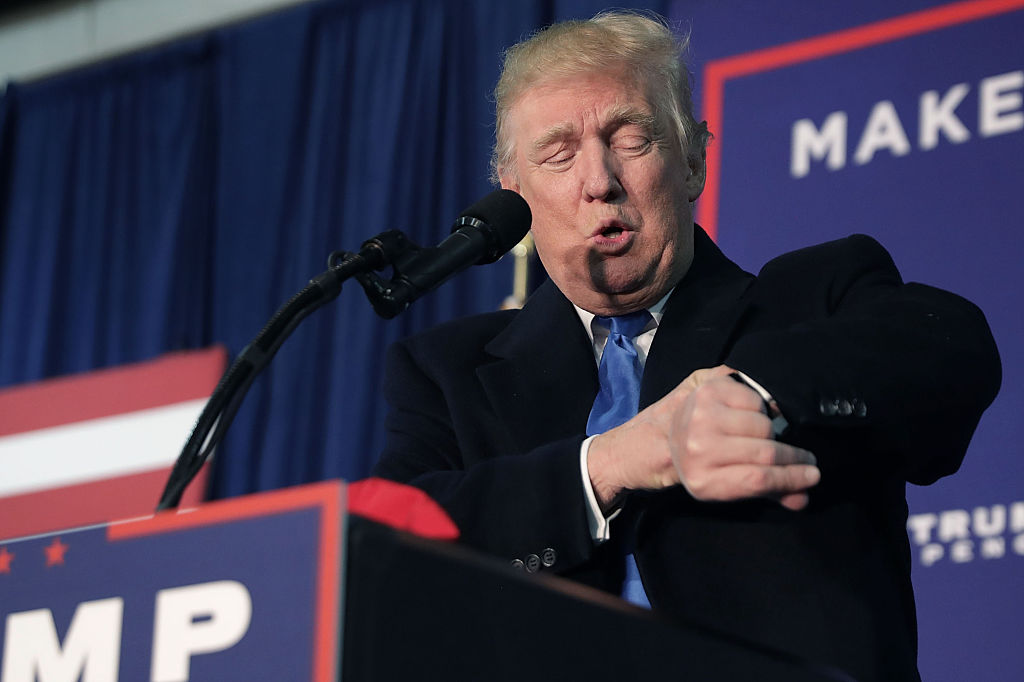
[477,281,598,451]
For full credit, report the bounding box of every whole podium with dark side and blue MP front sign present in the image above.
[0,482,850,682]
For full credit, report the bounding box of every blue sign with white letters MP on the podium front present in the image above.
[0,482,345,682]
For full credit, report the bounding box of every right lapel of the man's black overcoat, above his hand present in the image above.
[640,226,754,410]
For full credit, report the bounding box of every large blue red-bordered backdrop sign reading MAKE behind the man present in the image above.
[697,0,1024,682]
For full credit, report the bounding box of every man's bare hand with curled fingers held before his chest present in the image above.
[587,366,821,510]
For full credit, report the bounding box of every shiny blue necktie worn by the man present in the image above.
[587,310,651,608]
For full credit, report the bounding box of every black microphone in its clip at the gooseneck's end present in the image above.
[357,189,532,318]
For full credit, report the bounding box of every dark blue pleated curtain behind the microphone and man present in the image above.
[0,0,666,497]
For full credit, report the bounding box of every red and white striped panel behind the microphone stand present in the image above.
[0,347,227,539]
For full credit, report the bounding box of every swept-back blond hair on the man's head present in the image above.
[490,11,711,183]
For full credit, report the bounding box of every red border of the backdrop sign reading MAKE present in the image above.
[697,0,1024,239]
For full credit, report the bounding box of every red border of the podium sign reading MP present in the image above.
[106,481,345,682]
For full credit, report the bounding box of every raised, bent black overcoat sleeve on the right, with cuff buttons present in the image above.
[725,236,1000,484]
